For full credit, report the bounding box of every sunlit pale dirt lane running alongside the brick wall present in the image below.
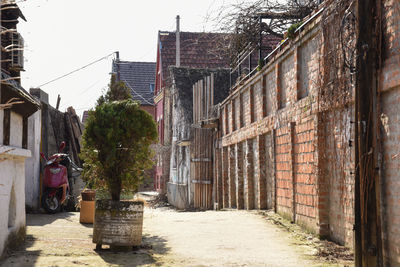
[2,208,352,266]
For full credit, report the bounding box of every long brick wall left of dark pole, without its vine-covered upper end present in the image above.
[217,7,354,243]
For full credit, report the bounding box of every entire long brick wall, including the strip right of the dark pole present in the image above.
[216,0,400,260]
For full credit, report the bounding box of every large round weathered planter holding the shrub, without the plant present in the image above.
[93,200,143,249]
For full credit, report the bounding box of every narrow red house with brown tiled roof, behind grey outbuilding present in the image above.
[154,31,229,193]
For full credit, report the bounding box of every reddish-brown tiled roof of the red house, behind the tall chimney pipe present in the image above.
[159,31,229,79]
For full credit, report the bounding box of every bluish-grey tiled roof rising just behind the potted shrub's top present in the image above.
[113,61,156,105]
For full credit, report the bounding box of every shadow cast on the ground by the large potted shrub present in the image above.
[96,234,170,266]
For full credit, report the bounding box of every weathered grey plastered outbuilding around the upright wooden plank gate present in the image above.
[167,67,229,209]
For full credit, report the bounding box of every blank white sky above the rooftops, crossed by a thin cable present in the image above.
[18,0,242,116]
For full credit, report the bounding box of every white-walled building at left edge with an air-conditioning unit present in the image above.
[0,3,39,256]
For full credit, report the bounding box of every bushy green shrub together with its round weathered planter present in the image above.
[82,77,157,249]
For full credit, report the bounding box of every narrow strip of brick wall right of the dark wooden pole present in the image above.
[380,0,400,266]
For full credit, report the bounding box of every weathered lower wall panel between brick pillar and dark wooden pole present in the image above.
[319,108,355,245]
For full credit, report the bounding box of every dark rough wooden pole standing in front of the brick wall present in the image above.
[354,0,383,267]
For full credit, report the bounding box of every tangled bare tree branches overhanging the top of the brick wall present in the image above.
[208,0,321,65]
